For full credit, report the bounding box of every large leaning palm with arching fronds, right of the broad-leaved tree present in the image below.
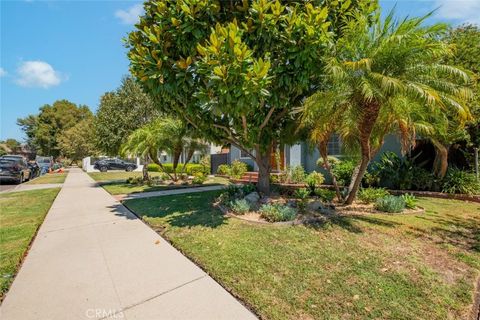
[308,11,471,204]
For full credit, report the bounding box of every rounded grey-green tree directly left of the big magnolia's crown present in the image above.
[94,77,159,156]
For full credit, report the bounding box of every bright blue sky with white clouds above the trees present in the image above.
[0,0,480,140]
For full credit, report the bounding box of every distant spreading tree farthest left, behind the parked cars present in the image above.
[17,100,92,157]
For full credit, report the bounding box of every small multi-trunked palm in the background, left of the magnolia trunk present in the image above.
[122,117,204,181]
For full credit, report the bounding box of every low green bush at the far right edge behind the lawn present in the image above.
[442,168,480,194]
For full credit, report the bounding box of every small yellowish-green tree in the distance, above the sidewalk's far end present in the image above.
[58,116,97,162]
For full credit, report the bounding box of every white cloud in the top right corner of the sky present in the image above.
[435,0,480,24]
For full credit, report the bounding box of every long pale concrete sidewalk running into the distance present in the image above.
[0,169,255,320]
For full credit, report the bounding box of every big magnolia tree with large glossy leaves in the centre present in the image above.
[127,0,375,193]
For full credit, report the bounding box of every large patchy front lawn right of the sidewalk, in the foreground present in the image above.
[125,192,480,320]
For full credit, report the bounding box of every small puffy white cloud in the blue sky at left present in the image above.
[16,61,63,89]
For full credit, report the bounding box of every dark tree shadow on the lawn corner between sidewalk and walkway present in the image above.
[124,191,227,228]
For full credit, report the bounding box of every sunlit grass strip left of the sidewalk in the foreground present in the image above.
[0,188,60,300]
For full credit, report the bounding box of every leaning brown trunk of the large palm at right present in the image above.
[345,100,380,204]
